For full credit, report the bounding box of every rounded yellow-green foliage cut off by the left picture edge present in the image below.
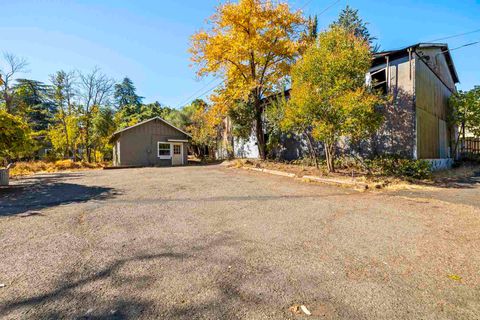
[0,110,33,162]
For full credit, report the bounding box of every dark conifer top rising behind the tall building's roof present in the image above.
[331,5,380,52]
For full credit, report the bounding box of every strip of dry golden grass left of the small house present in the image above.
[10,160,104,177]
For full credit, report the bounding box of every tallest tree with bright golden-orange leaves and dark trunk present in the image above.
[190,0,306,159]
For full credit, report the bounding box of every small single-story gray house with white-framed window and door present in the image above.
[110,117,191,166]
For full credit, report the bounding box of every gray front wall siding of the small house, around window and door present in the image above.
[117,120,188,166]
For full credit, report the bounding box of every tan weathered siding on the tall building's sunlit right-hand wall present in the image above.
[415,53,455,159]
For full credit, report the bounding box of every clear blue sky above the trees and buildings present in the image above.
[0,0,480,107]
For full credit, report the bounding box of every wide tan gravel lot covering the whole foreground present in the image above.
[0,165,480,319]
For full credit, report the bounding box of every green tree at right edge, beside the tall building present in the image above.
[447,86,480,154]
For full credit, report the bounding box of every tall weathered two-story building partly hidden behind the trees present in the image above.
[219,43,459,168]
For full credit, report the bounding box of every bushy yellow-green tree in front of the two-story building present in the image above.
[283,27,382,172]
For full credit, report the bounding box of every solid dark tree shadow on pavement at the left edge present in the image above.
[0,174,118,217]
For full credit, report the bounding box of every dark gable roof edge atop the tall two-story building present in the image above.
[373,43,460,83]
